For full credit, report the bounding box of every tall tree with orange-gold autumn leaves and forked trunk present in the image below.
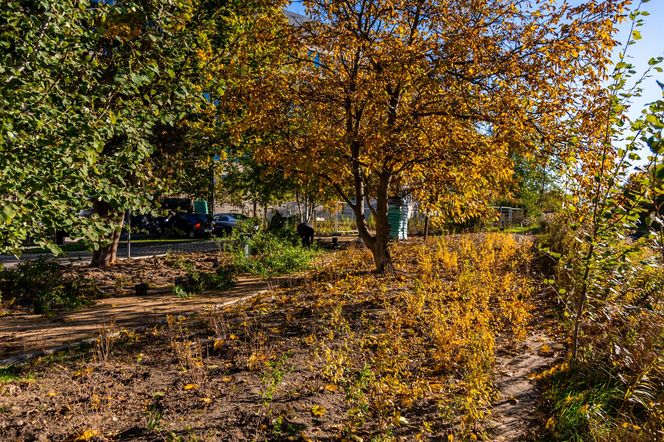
[249,0,624,271]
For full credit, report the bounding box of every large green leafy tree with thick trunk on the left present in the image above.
[0,0,288,265]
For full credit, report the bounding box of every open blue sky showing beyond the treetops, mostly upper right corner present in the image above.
[288,0,664,116]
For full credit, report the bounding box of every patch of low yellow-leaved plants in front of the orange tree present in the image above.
[310,233,532,437]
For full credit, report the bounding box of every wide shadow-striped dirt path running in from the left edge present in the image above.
[0,278,290,365]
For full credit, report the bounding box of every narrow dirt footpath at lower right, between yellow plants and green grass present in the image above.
[488,330,564,441]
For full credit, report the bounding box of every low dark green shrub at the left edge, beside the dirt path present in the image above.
[1,258,101,314]
